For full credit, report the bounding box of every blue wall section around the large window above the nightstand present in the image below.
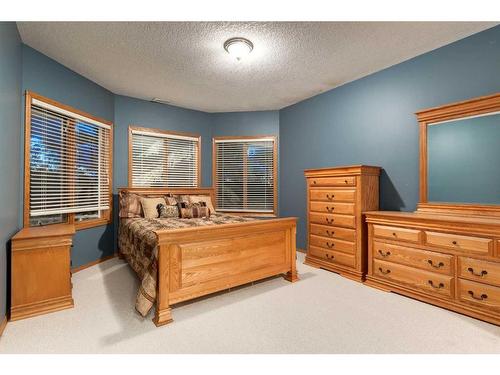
[19,45,115,267]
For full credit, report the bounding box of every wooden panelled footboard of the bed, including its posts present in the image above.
[153,218,298,326]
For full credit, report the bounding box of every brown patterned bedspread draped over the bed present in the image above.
[118,214,256,316]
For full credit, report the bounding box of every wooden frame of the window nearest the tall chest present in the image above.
[212,135,278,217]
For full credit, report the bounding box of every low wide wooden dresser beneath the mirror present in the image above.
[366,211,500,324]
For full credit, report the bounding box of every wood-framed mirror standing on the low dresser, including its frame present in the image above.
[416,93,500,216]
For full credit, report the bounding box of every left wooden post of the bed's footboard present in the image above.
[153,245,173,327]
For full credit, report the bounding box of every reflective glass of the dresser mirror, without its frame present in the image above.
[427,112,500,205]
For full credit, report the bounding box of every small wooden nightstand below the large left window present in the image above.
[10,224,75,320]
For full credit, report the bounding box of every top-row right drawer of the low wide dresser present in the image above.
[425,231,493,254]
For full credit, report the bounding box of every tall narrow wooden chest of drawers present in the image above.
[305,165,380,281]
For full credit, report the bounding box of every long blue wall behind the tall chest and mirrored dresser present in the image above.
[280,27,500,247]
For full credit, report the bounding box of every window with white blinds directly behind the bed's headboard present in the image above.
[129,127,201,187]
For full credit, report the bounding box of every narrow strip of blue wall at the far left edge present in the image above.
[0,22,22,323]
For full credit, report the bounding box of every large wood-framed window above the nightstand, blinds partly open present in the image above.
[24,92,112,228]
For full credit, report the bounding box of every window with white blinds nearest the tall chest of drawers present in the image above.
[213,137,277,214]
